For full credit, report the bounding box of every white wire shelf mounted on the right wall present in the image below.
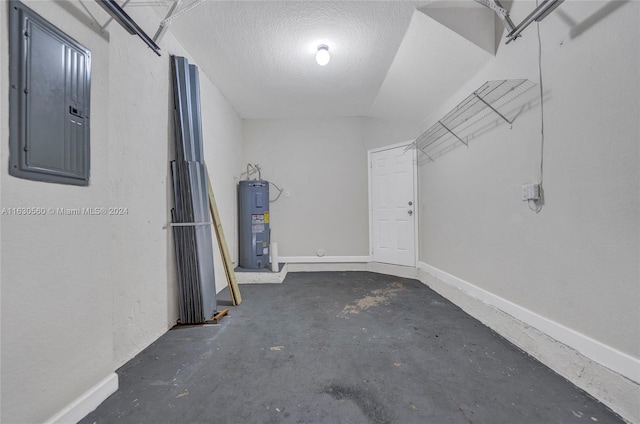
[408,79,535,159]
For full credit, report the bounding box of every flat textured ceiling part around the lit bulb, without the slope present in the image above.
[166,1,418,118]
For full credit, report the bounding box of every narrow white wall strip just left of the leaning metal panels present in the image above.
[107,2,176,366]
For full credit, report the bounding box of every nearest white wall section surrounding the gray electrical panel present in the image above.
[0,2,113,423]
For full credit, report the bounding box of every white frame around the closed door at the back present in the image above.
[367,140,420,267]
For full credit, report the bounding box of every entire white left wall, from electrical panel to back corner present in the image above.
[0,1,242,423]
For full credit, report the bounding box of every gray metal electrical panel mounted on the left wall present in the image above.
[9,1,91,186]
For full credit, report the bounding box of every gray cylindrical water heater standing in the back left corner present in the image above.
[238,180,269,269]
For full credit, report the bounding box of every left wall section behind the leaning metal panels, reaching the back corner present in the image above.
[109,8,242,365]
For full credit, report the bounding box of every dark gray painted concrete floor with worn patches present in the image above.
[81,272,624,424]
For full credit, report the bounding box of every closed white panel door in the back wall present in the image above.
[369,144,417,266]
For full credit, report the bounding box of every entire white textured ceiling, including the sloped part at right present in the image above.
[156,0,495,121]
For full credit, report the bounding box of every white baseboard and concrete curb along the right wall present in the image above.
[418,262,640,423]
